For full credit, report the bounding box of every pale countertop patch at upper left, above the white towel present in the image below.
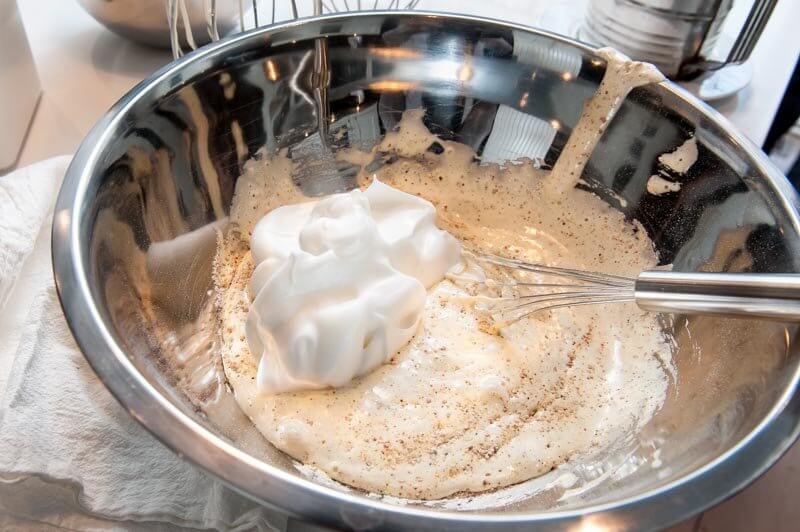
[17,0,172,166]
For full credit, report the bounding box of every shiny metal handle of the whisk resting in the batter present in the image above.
[634,271,800,321]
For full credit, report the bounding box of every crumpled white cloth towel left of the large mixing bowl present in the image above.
[0,157,286,530]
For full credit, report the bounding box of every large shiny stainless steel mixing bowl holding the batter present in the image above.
[53,12,800,530]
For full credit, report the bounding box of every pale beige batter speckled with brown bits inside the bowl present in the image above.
[215,50,670,499]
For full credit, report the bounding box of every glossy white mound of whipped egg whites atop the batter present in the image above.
[246,179,461,393]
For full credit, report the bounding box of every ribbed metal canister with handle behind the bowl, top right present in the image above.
[581,0,777,79]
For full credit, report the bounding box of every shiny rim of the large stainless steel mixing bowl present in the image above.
[52,10,800,530]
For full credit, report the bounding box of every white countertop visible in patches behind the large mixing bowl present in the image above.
[10,0,800,170]
